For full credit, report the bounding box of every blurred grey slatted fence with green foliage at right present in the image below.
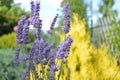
[92,16,120,53]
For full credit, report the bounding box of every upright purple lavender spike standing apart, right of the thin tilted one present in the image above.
[62,3,70,33]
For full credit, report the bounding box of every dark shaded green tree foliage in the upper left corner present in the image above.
[0,4,29,36]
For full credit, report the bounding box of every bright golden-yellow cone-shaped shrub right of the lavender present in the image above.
[60,14,120,80]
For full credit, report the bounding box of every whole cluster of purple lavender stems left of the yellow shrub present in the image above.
[14,0,73,80]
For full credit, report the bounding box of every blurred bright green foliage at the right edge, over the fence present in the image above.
[105,17,120,58]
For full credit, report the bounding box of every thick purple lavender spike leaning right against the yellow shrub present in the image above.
[56,36,73,59]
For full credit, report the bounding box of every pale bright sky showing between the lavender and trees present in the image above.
[14,0,120,30]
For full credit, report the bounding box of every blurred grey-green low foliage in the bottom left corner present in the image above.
[0,48,24,80]
